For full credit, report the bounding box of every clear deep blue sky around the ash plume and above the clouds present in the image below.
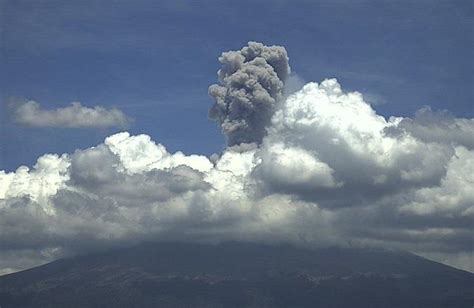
[0,0,474,170]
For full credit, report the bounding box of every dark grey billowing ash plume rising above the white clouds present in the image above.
[209,42,290,146]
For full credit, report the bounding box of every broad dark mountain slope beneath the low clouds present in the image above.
[0,242,474,308]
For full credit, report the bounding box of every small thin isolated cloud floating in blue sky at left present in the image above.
[14,101,130,128]
